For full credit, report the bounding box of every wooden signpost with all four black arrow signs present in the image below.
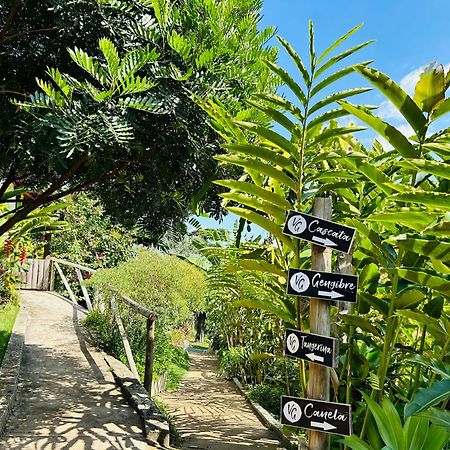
[280,197,358,450]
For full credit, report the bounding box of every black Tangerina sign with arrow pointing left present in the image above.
[284,328,339,367]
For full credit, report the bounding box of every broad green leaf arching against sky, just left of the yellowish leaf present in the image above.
[355,66,427,139]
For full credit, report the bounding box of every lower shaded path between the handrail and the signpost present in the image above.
[159,352,280,450]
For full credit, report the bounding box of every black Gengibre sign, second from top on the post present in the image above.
[287,269,358,303]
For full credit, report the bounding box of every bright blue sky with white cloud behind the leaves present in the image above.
[196,0,450,236]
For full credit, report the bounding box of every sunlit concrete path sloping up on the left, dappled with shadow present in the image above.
[0,291,153,450]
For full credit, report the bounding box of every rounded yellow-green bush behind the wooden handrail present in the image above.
[89,248,205,326]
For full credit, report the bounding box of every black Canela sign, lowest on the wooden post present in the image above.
[280,395,352,436]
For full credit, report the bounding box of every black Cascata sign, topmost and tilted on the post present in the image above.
[283,211,355,253]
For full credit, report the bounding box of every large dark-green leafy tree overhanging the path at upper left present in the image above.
[0,0,275,243]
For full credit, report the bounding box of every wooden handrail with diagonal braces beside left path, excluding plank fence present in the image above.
[49,257,157,395]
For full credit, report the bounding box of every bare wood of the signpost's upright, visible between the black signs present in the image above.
[308,197,331,450]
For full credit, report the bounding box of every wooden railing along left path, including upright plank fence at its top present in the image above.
[21,257,156,394]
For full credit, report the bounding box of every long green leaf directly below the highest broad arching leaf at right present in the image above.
[338,101,417,158]
